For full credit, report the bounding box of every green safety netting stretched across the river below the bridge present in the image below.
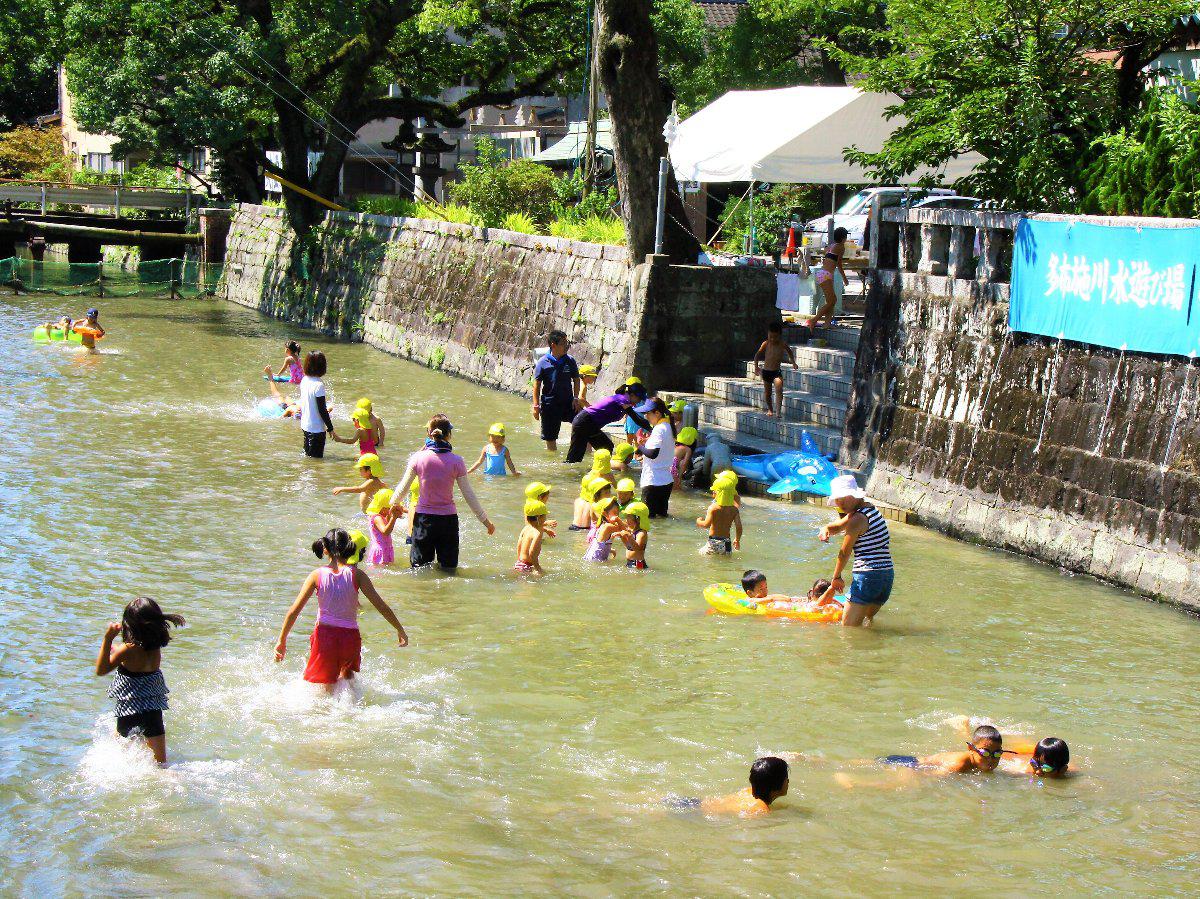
[0,257,221,296]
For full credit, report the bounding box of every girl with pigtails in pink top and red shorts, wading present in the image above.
[275,528,408,691]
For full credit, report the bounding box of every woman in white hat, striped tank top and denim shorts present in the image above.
[820,474,895,628]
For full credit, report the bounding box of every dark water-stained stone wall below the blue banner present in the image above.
[841,206,1200,611]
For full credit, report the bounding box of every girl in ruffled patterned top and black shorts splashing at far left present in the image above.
[96,597,184,765]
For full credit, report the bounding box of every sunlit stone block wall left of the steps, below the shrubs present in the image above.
[223,205,778,395]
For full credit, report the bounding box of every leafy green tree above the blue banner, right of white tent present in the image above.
[834,0,1193,211]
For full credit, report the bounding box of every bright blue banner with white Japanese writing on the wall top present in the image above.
[1008,218,1200,355]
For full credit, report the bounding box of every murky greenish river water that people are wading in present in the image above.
[0,296,1200,897]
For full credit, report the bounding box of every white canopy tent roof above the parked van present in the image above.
[668,86,983,185]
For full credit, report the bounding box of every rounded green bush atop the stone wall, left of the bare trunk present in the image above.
[450,137,558,228]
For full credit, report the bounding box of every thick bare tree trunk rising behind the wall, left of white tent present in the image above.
[596,0,700,265]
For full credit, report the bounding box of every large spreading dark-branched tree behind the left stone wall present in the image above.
[67,0,584,233]
